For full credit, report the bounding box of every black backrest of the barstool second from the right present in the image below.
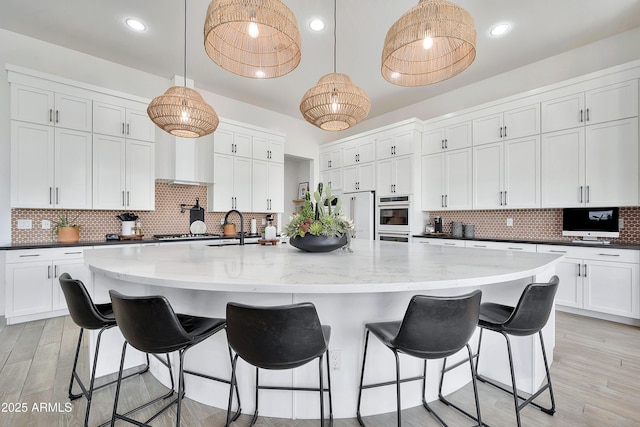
[392,290,482,359]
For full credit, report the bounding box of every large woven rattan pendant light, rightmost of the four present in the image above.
[382,0,476,86]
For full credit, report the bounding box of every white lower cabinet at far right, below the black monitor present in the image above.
[538,245,640,319]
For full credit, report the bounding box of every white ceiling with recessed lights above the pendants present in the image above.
[0,0,640,122]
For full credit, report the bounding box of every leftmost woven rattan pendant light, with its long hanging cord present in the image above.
[147,0,219,138]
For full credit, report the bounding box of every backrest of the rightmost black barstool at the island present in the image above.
[503,276,560,336]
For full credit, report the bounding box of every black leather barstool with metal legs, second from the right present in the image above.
[357,290,482,427]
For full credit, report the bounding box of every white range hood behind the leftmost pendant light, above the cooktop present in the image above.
[156,76,213,185]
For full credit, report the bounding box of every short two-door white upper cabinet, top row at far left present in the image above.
[11,84,92,132]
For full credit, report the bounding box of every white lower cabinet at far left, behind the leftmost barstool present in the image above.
[5,247,91,325]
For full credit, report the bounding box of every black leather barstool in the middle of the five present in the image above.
[227,302,333,426]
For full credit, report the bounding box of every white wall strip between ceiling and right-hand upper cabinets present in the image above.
[331,28,640,141]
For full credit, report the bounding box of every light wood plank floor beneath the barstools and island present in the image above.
[0,313,640,427]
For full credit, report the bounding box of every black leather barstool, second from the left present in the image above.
[109,290,240,426]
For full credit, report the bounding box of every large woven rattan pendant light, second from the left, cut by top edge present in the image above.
[204,0,302,79]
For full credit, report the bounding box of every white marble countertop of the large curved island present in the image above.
[84,239,561,294]
